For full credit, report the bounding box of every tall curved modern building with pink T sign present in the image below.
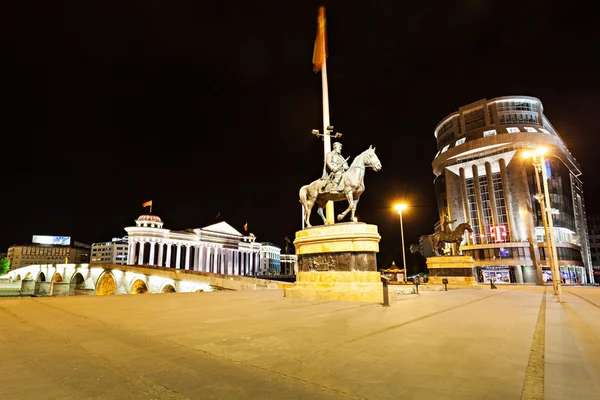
[432,96,594,284]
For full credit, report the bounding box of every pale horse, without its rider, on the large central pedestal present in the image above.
[300,146,381,228]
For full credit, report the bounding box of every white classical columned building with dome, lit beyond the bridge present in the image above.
[125,214,261,275]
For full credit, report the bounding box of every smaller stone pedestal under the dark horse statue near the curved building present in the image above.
[427,256,477,287]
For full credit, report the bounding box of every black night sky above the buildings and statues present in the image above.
[0,0,600,264]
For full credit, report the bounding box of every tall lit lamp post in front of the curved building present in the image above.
[523,147,563,303]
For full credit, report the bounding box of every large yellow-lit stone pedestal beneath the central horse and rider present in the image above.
[284,222,395,303]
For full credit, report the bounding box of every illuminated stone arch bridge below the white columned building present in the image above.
[2,264,281,296]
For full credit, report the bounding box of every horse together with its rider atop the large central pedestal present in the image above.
[300,142,381,228]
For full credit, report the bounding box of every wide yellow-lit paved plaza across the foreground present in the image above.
[0,286,600,400]
